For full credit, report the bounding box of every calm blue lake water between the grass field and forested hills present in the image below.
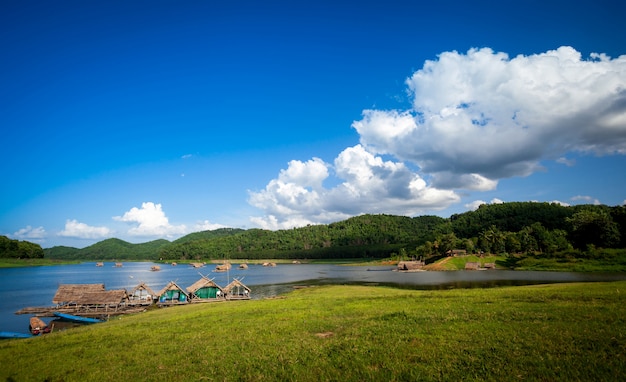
[0,262,626,332]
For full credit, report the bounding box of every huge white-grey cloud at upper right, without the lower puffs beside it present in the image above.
[353,47,626,190]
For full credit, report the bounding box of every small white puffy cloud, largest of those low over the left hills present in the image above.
[113,202,187,237]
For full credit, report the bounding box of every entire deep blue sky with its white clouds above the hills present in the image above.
[0,0,626,248]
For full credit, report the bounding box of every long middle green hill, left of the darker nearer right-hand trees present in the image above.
[160,215,447,260]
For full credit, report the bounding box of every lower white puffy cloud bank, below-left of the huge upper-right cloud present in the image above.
[248,145,459,229]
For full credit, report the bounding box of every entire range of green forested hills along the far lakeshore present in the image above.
[37,202,626,260]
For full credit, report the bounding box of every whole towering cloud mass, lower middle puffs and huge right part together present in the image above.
[249,46,626,229]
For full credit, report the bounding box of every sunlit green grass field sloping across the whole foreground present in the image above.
[0,282,626,381]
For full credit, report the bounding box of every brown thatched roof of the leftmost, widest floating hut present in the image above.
[52,284,128,306]
